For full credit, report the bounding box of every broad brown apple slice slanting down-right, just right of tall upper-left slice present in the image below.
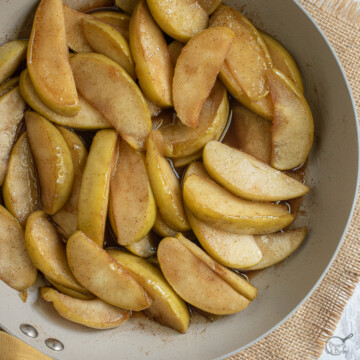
[71,53,151,149]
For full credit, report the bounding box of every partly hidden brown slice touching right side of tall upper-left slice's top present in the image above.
[64,5,92,52]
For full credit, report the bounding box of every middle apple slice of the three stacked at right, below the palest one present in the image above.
[183,175,294,234]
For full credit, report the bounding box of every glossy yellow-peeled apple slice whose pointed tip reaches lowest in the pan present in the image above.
[109,250,190,333]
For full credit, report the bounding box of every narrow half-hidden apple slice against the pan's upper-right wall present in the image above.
[260,32,304,94]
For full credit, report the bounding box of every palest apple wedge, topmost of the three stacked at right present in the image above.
[203,141,310,201]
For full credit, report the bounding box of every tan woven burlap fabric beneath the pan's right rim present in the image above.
[228,0,360,360]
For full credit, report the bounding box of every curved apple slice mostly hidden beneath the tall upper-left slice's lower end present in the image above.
[20,70,111,130]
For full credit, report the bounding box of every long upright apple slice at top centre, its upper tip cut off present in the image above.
[129,0,174,107]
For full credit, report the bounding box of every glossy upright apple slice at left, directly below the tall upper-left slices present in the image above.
[25,111,74,215]
